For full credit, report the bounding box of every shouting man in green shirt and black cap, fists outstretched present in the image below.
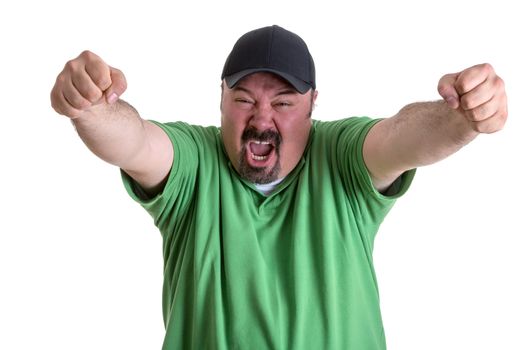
[51,26,507,350]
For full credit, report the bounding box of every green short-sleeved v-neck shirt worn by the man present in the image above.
[122,117,415,350]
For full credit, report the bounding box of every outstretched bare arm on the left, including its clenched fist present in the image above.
[51,51,173,194]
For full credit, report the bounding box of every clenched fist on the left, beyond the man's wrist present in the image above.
[51,51,127,119]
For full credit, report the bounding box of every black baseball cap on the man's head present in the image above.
[221,25,315,94]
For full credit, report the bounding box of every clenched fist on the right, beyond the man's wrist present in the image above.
[438,63,508,133]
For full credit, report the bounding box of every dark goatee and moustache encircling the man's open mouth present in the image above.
[239,128,282,184]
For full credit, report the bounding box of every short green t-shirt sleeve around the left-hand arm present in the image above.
[121,121,198,235]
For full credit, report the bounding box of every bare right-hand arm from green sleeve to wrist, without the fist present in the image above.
[363,101,478,190]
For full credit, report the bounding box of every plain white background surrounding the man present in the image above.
[0,0,525,350]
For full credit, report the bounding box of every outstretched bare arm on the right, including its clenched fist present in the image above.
[363,64,507,191]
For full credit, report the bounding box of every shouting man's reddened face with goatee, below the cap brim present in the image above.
[221,73,317,184]
